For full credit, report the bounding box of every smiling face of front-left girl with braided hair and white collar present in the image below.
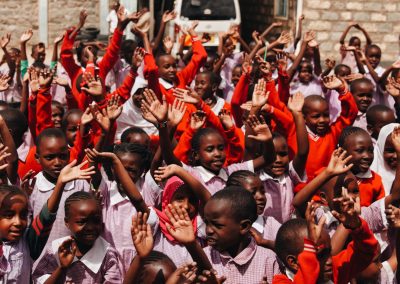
[65,199,104,246]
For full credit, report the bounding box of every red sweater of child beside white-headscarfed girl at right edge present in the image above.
[357,171,385,207]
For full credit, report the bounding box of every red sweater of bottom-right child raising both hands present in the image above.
[272,219,378,284]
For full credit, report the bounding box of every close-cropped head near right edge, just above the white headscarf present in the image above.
[367,105,396,139]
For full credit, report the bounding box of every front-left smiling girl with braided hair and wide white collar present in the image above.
[32,192,122,283]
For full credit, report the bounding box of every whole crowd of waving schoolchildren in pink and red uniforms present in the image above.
[0,3,400,284]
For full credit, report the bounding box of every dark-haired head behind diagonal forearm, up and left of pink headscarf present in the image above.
[114,143,153,182]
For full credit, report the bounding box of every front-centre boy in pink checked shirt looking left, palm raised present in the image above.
[168,186,279,283]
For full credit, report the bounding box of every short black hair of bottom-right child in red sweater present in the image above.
[275,219,307,265]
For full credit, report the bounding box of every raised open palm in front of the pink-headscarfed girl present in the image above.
[165,204,196,245]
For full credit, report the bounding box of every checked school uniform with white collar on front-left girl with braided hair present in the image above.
[32,236,123,284]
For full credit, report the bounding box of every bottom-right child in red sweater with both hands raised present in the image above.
[273,197,378,283]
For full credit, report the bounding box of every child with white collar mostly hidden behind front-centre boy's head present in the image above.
[226,171,281,250]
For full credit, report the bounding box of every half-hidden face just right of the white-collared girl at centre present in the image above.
[266,137,289,177]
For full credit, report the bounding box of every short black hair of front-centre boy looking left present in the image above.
[210,186,257,223]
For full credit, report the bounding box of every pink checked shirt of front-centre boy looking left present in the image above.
[204,238,279,284]
